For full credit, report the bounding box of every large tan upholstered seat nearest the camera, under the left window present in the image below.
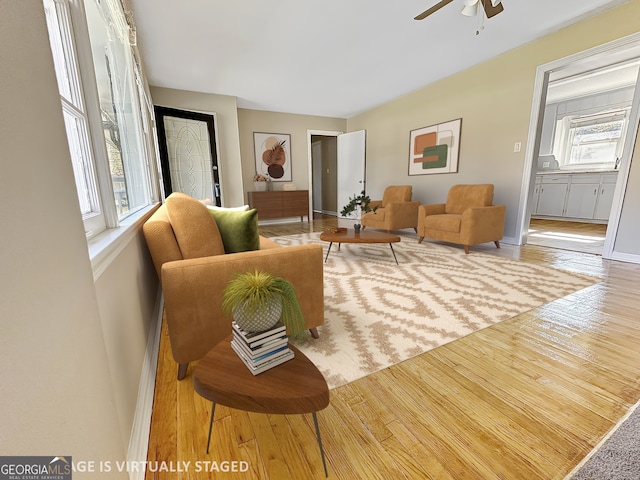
[143,193,324,379]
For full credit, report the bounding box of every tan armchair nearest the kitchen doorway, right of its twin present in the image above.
[418,184,507,253]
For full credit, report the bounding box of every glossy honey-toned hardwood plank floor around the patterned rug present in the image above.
[145,217,640,480]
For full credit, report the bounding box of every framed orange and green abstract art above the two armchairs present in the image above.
[409,118,462,175]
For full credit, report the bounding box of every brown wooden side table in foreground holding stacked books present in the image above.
[193,335,329,475]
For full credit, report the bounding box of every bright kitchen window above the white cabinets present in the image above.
[554,109,629,168]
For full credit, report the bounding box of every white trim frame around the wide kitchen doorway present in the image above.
[515,33,640,258]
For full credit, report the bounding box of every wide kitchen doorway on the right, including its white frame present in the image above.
[516,35,640,258]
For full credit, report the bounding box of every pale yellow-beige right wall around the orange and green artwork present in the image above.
[347,0,640,253]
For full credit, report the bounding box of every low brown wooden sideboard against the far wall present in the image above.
[248,190,309,221]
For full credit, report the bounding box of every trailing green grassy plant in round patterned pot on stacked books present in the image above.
[222,270,306,336]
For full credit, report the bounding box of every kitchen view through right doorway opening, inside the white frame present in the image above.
[527,56,640,255]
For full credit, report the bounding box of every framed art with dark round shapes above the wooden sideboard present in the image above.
[253,132,291,182]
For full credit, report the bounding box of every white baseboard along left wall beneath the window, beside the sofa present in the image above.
[127,287,164,480]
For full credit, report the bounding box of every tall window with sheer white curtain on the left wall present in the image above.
[43,0,154,236]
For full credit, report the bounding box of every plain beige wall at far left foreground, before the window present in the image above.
[0,0,129,472]
